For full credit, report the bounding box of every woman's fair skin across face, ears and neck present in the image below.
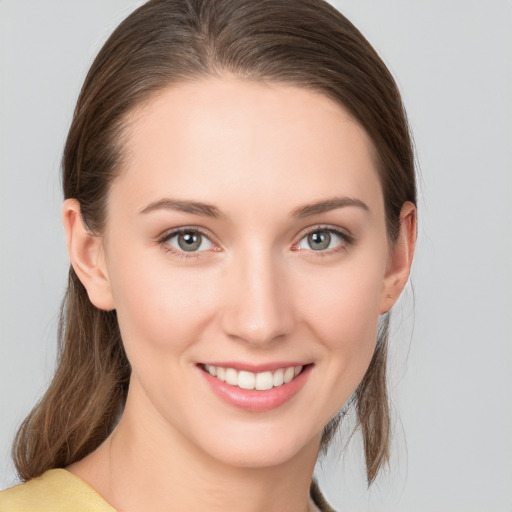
[63,75,416,512]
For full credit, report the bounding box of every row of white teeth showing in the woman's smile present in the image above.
[201,364,309,391]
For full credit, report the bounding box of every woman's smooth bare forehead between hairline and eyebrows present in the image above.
[112,76,382,218]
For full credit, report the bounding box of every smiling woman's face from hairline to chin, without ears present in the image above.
[99,76,396,466]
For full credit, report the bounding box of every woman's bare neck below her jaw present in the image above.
[77,380,319,512]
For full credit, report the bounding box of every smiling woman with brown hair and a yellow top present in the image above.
[0,0,416,511]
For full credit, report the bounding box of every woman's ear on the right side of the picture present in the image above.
[379,201,417,315]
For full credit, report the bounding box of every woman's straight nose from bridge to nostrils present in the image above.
[222,246,294,346]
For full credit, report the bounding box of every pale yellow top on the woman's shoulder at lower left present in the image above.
[0,469,114,512]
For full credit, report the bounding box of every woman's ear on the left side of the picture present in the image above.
[62,199,115,311]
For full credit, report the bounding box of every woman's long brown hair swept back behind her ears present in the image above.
[13,0,416,483]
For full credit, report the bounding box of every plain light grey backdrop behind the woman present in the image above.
[0,0,512,512]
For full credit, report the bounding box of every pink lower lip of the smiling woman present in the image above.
[198,364,313,412]
